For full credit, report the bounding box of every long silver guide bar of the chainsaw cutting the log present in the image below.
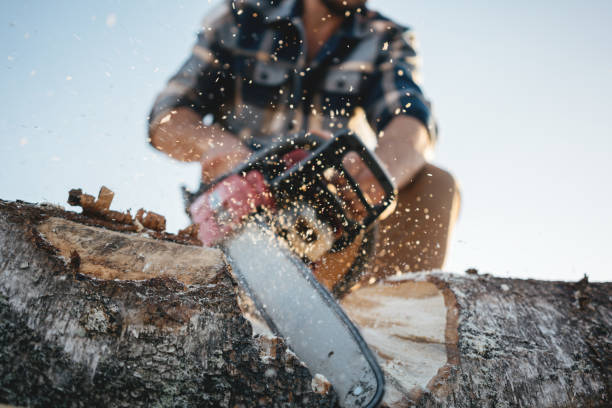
[223,220,384,407]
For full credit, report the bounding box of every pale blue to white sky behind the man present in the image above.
[0,0,612,280]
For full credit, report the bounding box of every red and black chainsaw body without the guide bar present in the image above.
[187,132,396,265]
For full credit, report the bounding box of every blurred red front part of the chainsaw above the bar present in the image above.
[189,170,274,246]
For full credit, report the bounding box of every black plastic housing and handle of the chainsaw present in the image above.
[184,131,396,252]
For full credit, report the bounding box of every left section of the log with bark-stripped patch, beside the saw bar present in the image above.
[0,201,335,407]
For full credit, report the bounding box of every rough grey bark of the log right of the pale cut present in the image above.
[419,274,612,407]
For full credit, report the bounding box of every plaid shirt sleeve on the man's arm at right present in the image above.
[364,29,437,142]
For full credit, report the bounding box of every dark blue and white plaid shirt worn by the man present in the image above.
[149,0,436,148]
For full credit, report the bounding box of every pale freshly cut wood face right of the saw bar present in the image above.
[342,280,457,407]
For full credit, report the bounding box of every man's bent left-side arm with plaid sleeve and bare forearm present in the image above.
[149,3,250,182]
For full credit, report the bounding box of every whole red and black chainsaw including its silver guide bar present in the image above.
[185,132,396,407]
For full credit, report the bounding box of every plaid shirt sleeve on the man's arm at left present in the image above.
[148,2,233,125]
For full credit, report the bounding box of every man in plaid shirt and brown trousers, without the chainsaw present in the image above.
[149,0,459,288]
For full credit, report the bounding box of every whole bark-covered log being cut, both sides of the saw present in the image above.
[0,200,612,407]
